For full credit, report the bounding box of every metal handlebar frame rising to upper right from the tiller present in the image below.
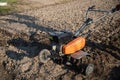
[74,4,120,37]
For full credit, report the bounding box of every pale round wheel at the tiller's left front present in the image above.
[38,49,51,63]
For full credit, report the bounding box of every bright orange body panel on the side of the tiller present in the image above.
[63,37,85,54]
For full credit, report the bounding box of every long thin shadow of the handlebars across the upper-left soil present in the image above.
[4,13,55,33]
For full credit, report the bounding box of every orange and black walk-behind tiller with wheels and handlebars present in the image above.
[39,4,120,74]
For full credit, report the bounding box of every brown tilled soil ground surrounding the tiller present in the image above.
[0,0,120,80]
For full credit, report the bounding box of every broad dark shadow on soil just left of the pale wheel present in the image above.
[6,38,50,60]
